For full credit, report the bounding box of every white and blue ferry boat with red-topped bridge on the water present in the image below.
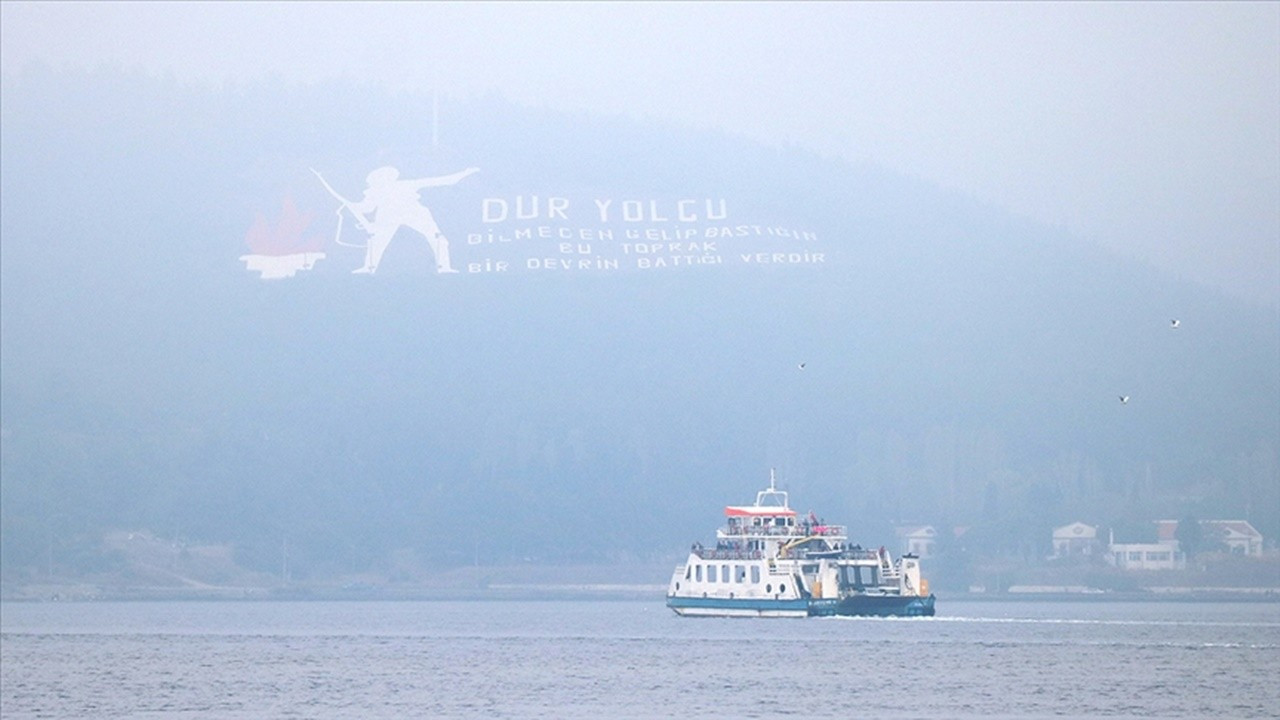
[667,470,934,618]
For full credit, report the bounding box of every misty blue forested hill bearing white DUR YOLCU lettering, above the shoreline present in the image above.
[0,70,1280,574]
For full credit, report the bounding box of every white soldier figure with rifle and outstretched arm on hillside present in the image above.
[312,167,480,274]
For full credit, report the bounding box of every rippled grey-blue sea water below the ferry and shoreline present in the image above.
[0,598,1280,720]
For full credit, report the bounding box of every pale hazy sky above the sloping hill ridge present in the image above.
[0,1,1280,306]
